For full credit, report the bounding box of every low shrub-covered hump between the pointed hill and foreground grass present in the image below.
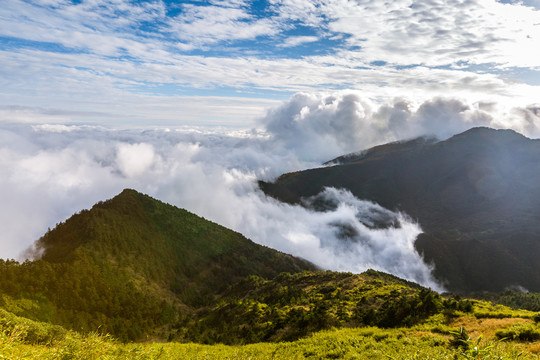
[180,271,452,344]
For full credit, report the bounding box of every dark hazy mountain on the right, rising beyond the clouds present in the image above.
[260,128,540,291]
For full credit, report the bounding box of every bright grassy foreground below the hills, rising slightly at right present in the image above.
[0,315,540,359]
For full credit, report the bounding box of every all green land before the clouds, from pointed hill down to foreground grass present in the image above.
[0,190,540,359]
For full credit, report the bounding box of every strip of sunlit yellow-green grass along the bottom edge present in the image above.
[0,325,540,360]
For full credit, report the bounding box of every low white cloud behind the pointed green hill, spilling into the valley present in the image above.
[0,115,437,287]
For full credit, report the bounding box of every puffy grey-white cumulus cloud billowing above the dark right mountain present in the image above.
[261,91,540,161]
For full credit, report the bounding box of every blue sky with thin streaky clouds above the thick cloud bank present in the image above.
[0,0,540,128]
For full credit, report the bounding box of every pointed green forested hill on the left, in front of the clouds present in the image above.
[0,189,316,340]
